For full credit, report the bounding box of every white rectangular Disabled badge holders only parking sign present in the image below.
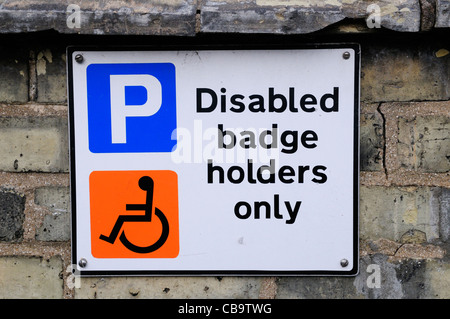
[67,44,360,275]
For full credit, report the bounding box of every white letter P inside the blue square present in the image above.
[110,74,162,143]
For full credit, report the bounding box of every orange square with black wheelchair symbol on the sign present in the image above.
[89,170,179,258]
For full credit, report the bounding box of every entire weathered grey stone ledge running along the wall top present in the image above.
[0,0,450,36]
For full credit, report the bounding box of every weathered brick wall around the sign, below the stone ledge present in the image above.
[0,1,450,299]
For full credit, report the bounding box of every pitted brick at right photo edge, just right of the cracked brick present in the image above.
[397,116,450,173]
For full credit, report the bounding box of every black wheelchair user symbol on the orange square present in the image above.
[100,176,169,254]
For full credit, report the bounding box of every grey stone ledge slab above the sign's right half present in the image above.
[201,0,420,34]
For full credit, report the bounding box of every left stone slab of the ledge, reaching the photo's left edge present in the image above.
[0,0,196,35]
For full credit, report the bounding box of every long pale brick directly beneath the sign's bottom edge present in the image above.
[75,277,263,299]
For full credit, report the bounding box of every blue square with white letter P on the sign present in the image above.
[86,63,177,153]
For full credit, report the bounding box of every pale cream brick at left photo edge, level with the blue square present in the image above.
[0,117,69,172]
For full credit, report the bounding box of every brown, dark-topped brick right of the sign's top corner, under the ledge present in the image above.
[361,44,450,102]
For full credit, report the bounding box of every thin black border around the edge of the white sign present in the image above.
[66,42,361,277]
